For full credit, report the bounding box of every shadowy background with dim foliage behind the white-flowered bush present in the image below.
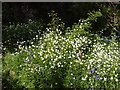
[2,2,120,53]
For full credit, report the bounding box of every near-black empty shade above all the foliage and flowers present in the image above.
[3,2,99,26]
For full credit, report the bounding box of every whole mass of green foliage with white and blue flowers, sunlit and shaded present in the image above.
[2,3,120,89]
